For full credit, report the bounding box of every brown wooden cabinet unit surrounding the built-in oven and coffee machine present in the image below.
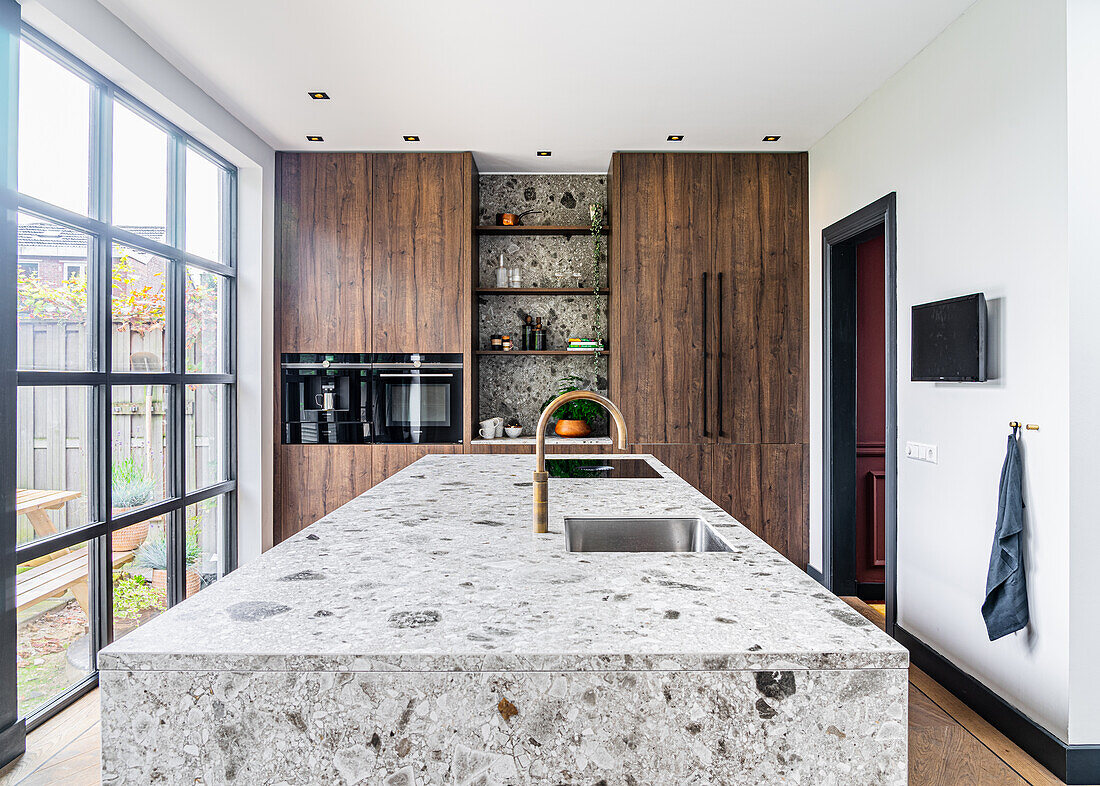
[273,153,477,543]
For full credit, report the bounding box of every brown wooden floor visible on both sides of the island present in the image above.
[0,598,1082,786]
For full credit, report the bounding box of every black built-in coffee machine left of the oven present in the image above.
[283,353,373,444]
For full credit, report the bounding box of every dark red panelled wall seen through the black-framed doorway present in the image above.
[856,227,887,583]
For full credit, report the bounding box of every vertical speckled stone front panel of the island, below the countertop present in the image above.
[101,669,908,786]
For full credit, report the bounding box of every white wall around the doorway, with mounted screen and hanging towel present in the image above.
[810,0,1073,741]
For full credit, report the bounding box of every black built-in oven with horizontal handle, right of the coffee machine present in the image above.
[371,354,462,444]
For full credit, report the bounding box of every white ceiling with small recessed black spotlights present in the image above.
[92,0,972,171]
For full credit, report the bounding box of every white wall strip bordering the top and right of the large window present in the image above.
[22,0,275,563]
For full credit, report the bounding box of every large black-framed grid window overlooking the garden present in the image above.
[8,26,237,728]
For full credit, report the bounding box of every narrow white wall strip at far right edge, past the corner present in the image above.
[1066,0,1100,744]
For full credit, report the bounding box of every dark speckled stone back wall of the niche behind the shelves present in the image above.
[477,175,608,436]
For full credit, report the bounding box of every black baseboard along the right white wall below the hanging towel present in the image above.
[894,626,1100,786]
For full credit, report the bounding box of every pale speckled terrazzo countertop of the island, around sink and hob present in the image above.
[99,455,908,672]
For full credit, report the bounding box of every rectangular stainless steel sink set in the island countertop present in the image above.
[565,516,733,552]
